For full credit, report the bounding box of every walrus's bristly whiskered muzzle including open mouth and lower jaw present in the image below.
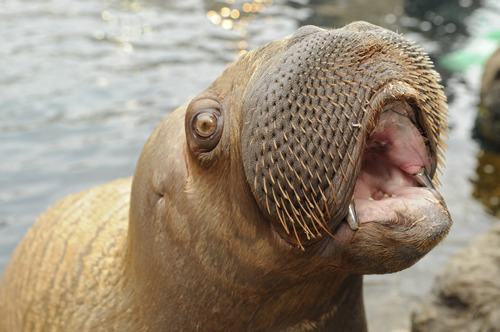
[241,23,451,273]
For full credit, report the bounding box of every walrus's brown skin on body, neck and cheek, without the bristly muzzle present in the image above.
[0,23,450,331]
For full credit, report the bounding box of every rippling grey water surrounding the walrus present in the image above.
[0,0,500,331]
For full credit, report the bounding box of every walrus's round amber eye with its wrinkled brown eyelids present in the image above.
[185,96,224,165]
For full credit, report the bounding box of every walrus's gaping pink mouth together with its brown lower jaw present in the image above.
[322,95,452,273]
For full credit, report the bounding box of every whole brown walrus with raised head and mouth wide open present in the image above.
[0,22,452,331]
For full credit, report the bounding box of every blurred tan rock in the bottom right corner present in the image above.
[412,222,500,332]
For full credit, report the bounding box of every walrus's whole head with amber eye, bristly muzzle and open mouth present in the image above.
[136,22,452,278]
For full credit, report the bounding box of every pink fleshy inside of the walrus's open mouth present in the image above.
[348,110,439,230]
